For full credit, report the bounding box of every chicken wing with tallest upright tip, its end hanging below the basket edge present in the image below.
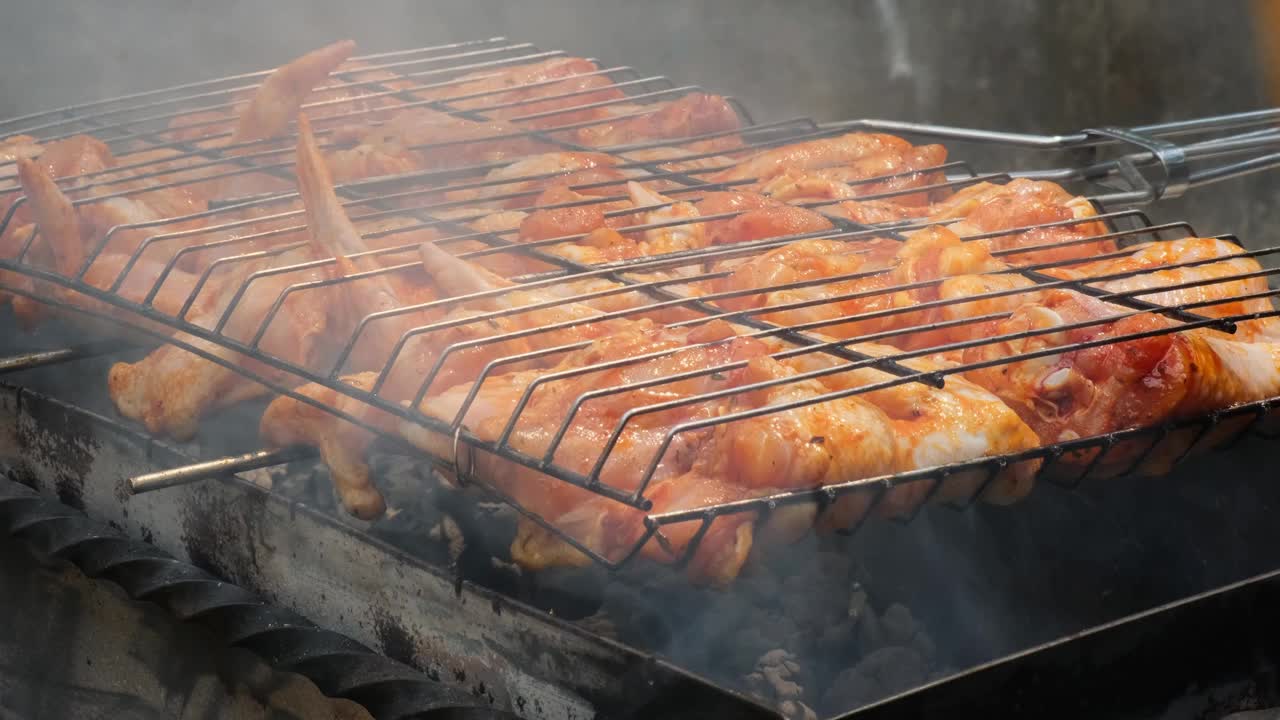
[261,113,640,518]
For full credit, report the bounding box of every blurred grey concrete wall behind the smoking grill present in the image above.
[0,0,1280,245]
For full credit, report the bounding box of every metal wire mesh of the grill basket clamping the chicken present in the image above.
[0,38,1280,568]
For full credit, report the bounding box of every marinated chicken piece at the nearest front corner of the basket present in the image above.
[402,323,892,583]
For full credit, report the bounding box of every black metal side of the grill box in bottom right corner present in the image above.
[840,570,1280,720]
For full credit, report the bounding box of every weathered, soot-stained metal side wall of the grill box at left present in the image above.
[0,386,773,719]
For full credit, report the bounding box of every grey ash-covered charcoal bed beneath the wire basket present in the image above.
[264,455,950,720]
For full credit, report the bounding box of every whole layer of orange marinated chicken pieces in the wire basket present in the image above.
[10,41,1280,594]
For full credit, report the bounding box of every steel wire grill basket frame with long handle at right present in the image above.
[0,38,1280,568]
